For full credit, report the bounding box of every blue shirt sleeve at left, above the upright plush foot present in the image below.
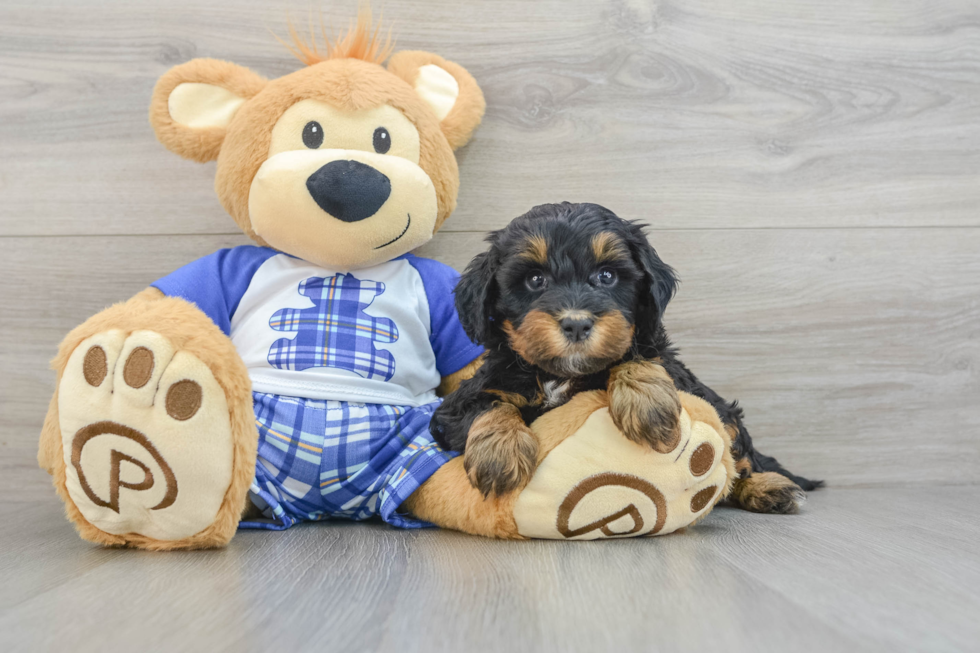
[151,245,279,335]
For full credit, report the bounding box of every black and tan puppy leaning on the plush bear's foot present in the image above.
[430,203,821,513]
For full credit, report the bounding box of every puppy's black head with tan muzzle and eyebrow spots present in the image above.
[457,204,673,377]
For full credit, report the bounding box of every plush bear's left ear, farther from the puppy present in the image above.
[150,59,266,163]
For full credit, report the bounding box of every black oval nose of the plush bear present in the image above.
[306,161,391,222]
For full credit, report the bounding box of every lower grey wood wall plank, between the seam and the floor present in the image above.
[0,228,980,496]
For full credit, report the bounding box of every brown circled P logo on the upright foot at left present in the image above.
[71,421,177,513]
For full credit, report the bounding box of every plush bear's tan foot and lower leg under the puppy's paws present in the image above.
[405,392,736,540]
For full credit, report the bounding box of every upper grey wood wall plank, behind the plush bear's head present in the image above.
[0,0,980,235]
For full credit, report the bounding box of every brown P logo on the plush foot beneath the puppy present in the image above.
[557,473,667,538]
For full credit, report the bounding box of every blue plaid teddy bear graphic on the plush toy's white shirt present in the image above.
[268,274,398,381]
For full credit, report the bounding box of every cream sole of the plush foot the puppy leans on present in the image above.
[514,408,731,539]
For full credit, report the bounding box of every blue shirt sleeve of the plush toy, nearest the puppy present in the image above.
[406,255,483,376]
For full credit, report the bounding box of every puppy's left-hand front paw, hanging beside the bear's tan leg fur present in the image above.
[463,404,538,497]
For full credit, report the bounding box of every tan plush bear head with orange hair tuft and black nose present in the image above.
[150,14,485,269]
